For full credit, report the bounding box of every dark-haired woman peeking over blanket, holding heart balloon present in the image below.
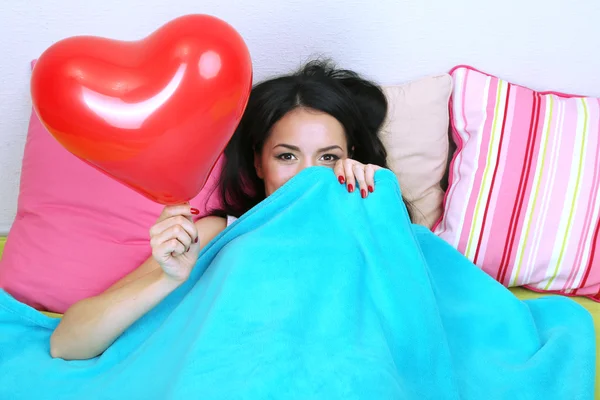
[50,62,412,359]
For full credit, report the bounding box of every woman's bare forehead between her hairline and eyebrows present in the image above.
[267,107,346,147]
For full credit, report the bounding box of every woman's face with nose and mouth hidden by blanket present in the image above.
[254,107,348,196]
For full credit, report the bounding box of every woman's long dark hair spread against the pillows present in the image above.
[215,61,411,217]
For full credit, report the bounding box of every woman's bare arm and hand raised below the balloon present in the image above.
[50,212,226,360]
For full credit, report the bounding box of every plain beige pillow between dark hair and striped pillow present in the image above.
[380,74,452,228]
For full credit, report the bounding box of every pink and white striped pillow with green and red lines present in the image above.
[434,66,600,301]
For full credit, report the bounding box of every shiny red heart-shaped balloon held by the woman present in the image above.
[31,15,252,204]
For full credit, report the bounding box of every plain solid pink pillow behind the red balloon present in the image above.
[0,63,220,313]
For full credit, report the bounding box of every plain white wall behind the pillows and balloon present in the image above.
[0,0,600,234]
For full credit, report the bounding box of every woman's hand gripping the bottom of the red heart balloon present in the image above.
[150,204,200,282]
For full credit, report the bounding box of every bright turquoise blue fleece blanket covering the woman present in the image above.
[0,167,595,400]
